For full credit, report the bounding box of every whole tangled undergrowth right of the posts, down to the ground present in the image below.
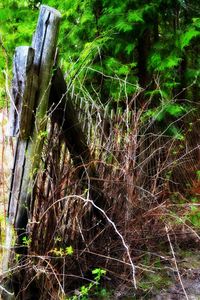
[1,86,200,299]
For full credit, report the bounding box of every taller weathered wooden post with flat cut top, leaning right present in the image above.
[15,5,61,228]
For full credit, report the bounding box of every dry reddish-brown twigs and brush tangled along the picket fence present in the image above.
[14,98,200,299]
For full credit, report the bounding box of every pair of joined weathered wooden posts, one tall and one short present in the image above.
[3,5,61,299]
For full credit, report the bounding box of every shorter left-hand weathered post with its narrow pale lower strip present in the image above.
[3,46,37,271]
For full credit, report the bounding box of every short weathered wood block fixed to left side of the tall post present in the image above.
[9,46,37,139]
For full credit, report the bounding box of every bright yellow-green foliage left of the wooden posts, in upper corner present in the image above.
[0,0,37,108]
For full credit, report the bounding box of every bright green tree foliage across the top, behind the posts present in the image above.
[0,0,200,108]
